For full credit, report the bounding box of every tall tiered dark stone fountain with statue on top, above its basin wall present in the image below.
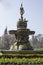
[9,4,35,50]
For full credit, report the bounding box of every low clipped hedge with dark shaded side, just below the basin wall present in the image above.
[0,54,43,58]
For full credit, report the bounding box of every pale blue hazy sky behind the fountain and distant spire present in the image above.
[0,0,43,36]
